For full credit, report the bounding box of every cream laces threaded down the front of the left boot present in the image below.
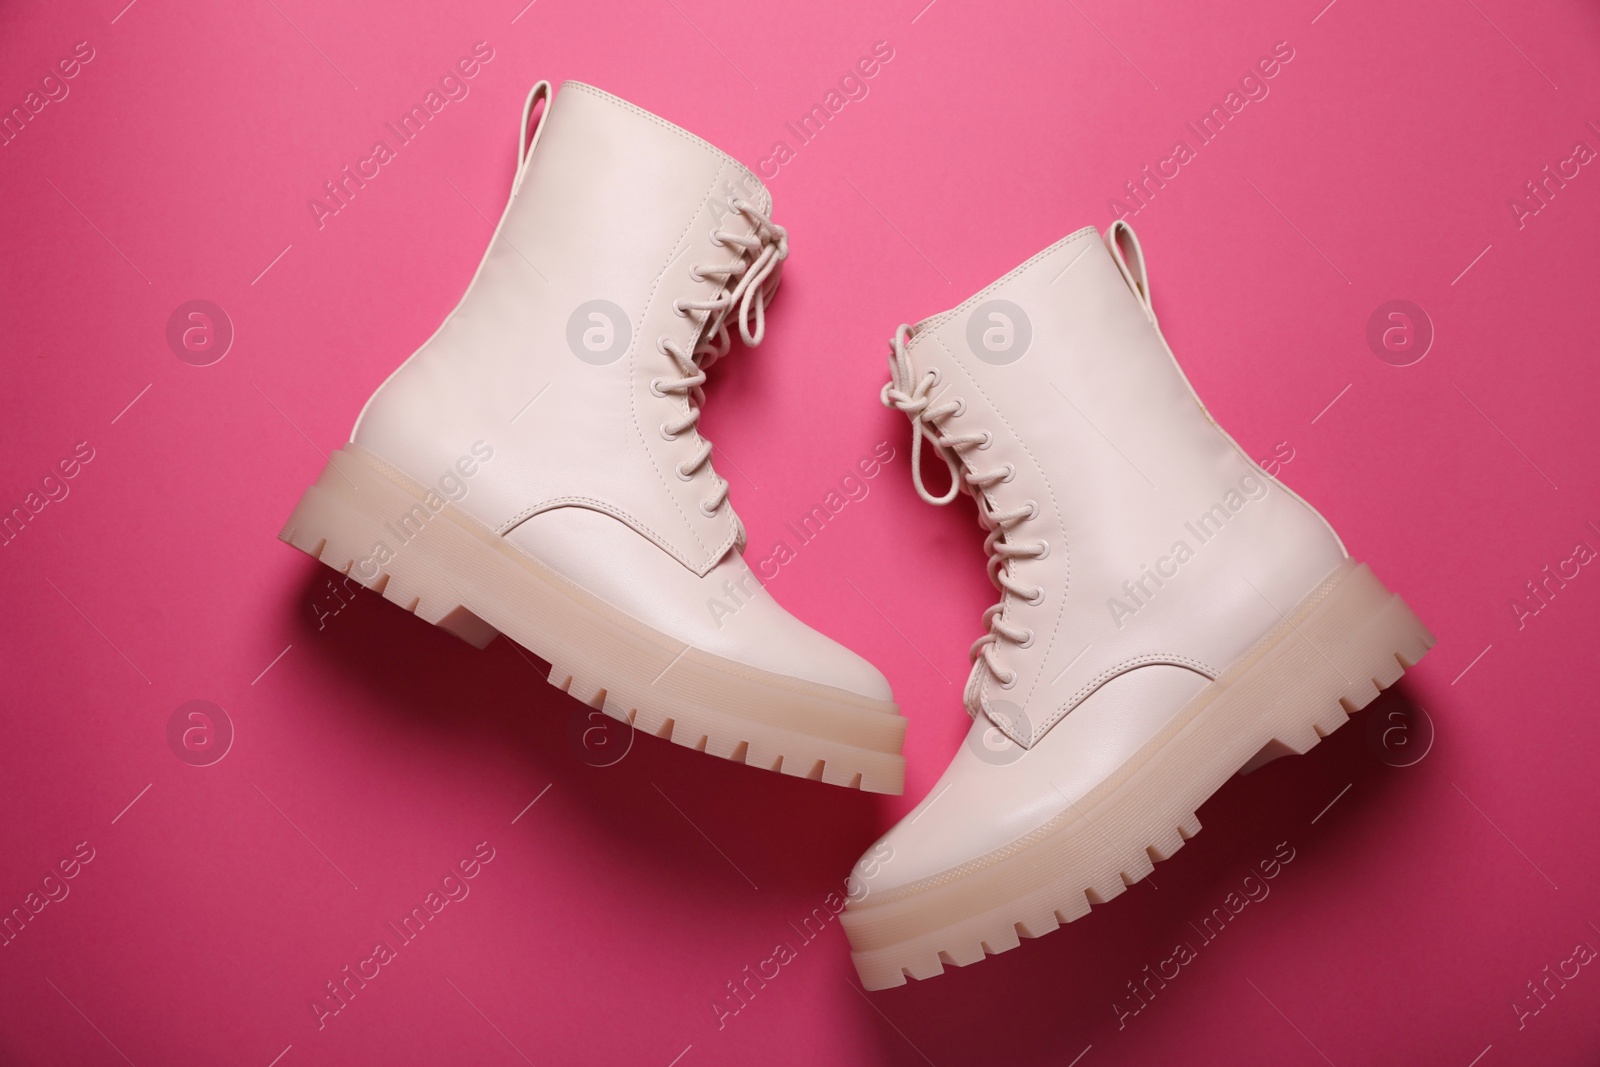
[650,200,789,517]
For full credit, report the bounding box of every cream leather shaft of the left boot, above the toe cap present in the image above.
[352,82,771,573]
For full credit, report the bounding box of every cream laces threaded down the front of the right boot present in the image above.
[878,325,1050,715]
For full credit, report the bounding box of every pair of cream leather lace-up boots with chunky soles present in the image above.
[280,82,1434,989]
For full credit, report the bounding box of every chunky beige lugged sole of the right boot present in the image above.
[842,561,1434,989]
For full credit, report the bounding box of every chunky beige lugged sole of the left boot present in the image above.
[278,445,906,793]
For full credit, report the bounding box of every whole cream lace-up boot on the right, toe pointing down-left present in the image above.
[843,222,1434,989]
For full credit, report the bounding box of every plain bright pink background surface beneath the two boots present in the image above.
[0,0,1600,1067]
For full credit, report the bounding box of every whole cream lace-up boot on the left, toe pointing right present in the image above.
[280,82,906,793]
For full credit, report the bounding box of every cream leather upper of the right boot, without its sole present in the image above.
[850,224,1344,902]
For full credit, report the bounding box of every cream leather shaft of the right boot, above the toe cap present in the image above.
[896,227,1344,745]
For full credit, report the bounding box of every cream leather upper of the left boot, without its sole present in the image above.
[352,82,893,702]
